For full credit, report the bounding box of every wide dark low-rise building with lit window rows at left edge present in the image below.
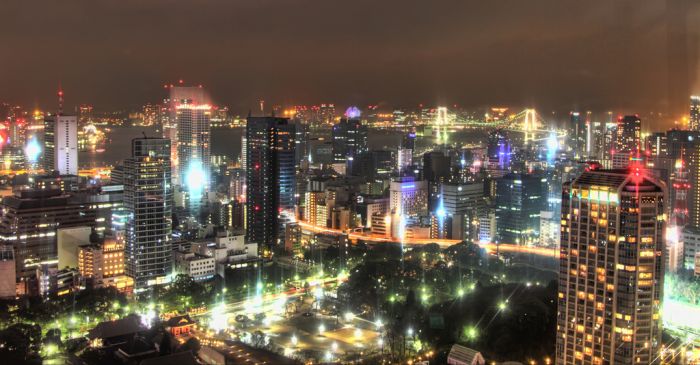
[0,188,96,277]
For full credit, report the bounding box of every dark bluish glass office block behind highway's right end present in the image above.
[496,173,547,245]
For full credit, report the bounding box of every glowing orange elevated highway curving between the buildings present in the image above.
[297,221,559,258]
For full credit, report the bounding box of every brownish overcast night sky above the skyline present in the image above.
[0,0,700,119]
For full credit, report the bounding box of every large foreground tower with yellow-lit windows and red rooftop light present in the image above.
[556,170,665,364]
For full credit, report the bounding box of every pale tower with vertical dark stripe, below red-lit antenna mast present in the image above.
[44,115,78,175]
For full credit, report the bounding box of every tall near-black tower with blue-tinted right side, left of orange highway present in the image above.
[246,117,296,247]
